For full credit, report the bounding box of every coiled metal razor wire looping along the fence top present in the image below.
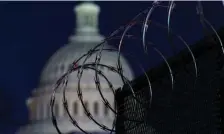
[50,1,224,134]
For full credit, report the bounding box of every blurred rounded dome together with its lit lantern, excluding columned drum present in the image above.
[39,2,133,90]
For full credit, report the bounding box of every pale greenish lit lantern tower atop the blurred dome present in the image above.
[69,1,104,45]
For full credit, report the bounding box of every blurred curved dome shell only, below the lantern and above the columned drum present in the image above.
[39,38,133,90]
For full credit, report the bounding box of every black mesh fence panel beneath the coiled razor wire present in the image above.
[116,41,222,134]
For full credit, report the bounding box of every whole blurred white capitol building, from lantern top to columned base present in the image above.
[19,2,133,134]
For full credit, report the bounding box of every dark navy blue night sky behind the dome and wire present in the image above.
[0,2,224,134]
